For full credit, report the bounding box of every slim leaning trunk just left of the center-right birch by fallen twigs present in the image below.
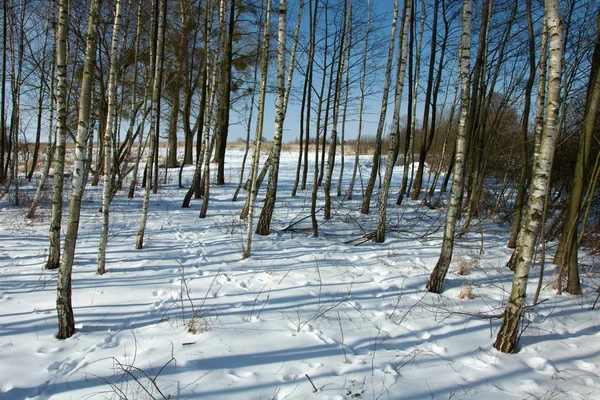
[360,0,398,214]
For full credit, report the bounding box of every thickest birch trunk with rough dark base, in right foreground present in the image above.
[494,0,563,353]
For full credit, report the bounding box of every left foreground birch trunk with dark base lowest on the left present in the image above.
[56,0,99,339]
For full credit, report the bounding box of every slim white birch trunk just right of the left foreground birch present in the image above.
[96,0,122,275]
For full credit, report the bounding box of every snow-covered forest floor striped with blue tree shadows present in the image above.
[0,152,600,400]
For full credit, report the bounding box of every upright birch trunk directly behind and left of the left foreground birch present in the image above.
[46,0,69,272]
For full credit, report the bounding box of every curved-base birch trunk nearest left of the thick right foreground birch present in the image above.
[426,0,472,293]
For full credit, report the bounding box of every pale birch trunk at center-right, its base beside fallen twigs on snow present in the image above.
[374,0,413,243]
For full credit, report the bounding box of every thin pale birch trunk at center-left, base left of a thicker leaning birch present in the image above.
[242,0,271,259]
